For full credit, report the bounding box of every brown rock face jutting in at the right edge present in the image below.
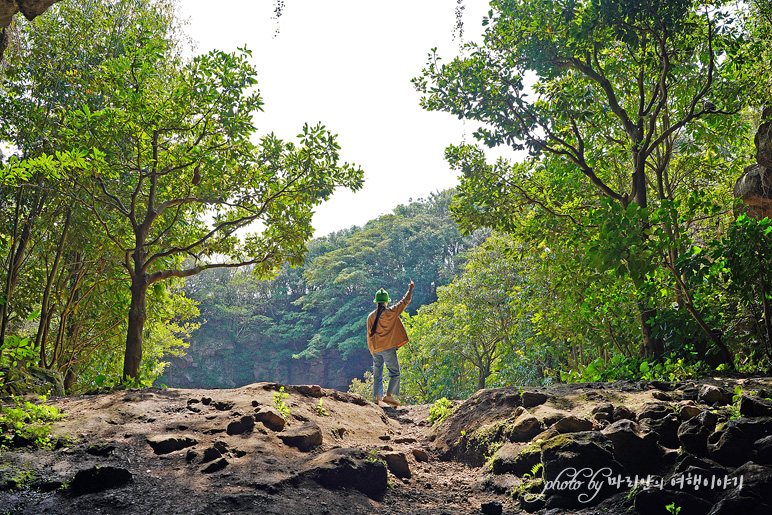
[733,106,772,219]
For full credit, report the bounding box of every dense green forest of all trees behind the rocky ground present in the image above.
[0,0,772,402]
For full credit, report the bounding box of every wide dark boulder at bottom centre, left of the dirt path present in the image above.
[298,448,387,500]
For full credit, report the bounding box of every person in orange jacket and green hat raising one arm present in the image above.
[367,281,415,406]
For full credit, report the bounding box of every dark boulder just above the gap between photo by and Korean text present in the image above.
[602,420,663,473]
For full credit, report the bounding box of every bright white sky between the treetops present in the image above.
[175,0,512,236]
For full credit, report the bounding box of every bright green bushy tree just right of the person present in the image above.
[400,234,544,402]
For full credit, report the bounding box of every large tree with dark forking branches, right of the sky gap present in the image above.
[414,0,759,362]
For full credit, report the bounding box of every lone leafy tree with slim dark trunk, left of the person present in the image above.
[72,43,362,378]
